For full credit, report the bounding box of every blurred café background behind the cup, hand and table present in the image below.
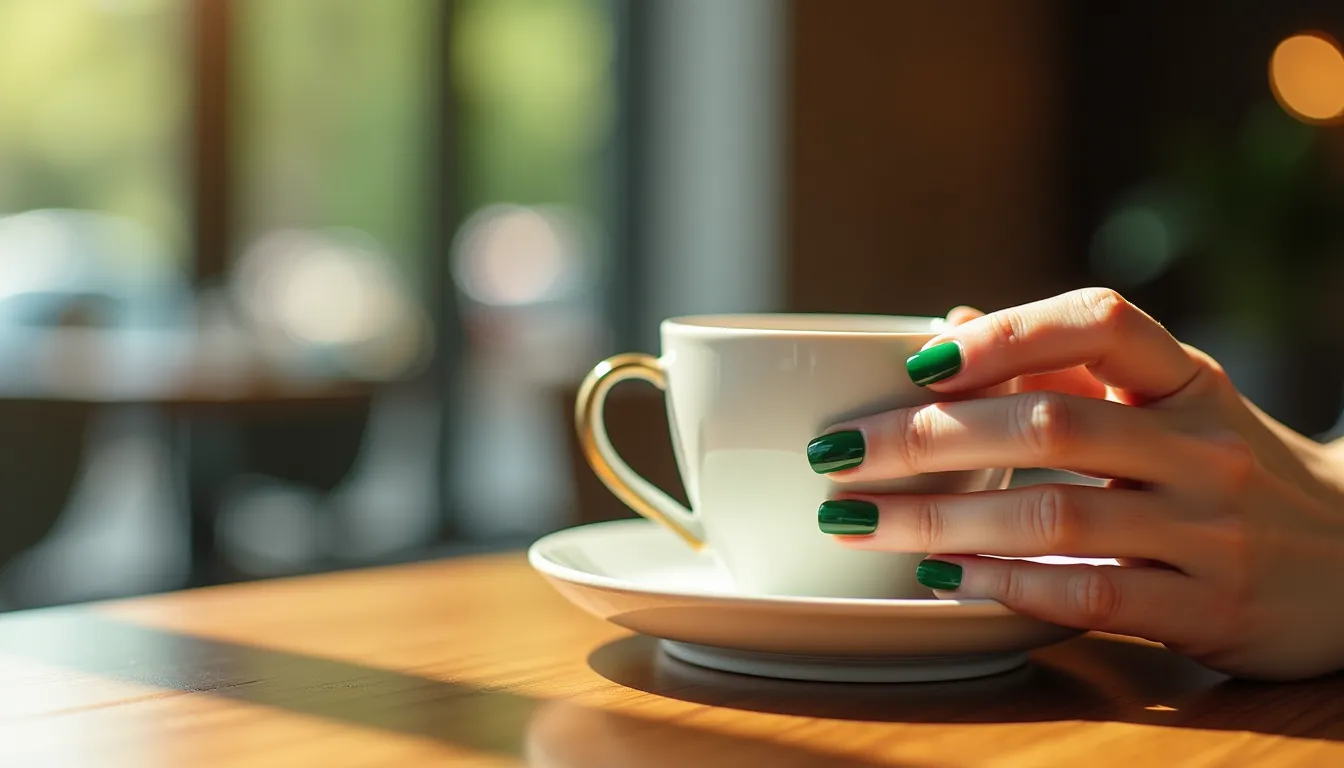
[0,0,1344,609]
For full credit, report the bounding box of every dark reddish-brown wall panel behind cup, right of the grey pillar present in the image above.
[786,0,1073,313]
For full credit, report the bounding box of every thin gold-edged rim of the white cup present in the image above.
[660,312,946,339]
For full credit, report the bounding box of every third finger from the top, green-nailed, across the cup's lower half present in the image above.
[817,483,1198,562]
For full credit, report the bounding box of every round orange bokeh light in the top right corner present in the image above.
[1270,32,1344,122]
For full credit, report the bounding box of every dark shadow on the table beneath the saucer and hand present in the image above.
[589,635,1344,741]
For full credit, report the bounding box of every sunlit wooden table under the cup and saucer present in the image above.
[0,553,1344,768]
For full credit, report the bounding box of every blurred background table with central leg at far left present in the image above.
[0,325,394,585]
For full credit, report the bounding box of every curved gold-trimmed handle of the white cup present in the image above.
[574,352,704,549]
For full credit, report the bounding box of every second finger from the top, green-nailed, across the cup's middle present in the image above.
[806,391,1236,484]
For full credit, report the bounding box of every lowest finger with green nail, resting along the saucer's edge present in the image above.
[917,555,1214,644]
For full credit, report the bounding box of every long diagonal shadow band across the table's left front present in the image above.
[0,609,913,768]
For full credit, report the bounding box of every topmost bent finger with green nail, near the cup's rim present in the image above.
[907,288,1200,401]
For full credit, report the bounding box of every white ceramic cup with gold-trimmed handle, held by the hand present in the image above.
[575,313,1009,597]
